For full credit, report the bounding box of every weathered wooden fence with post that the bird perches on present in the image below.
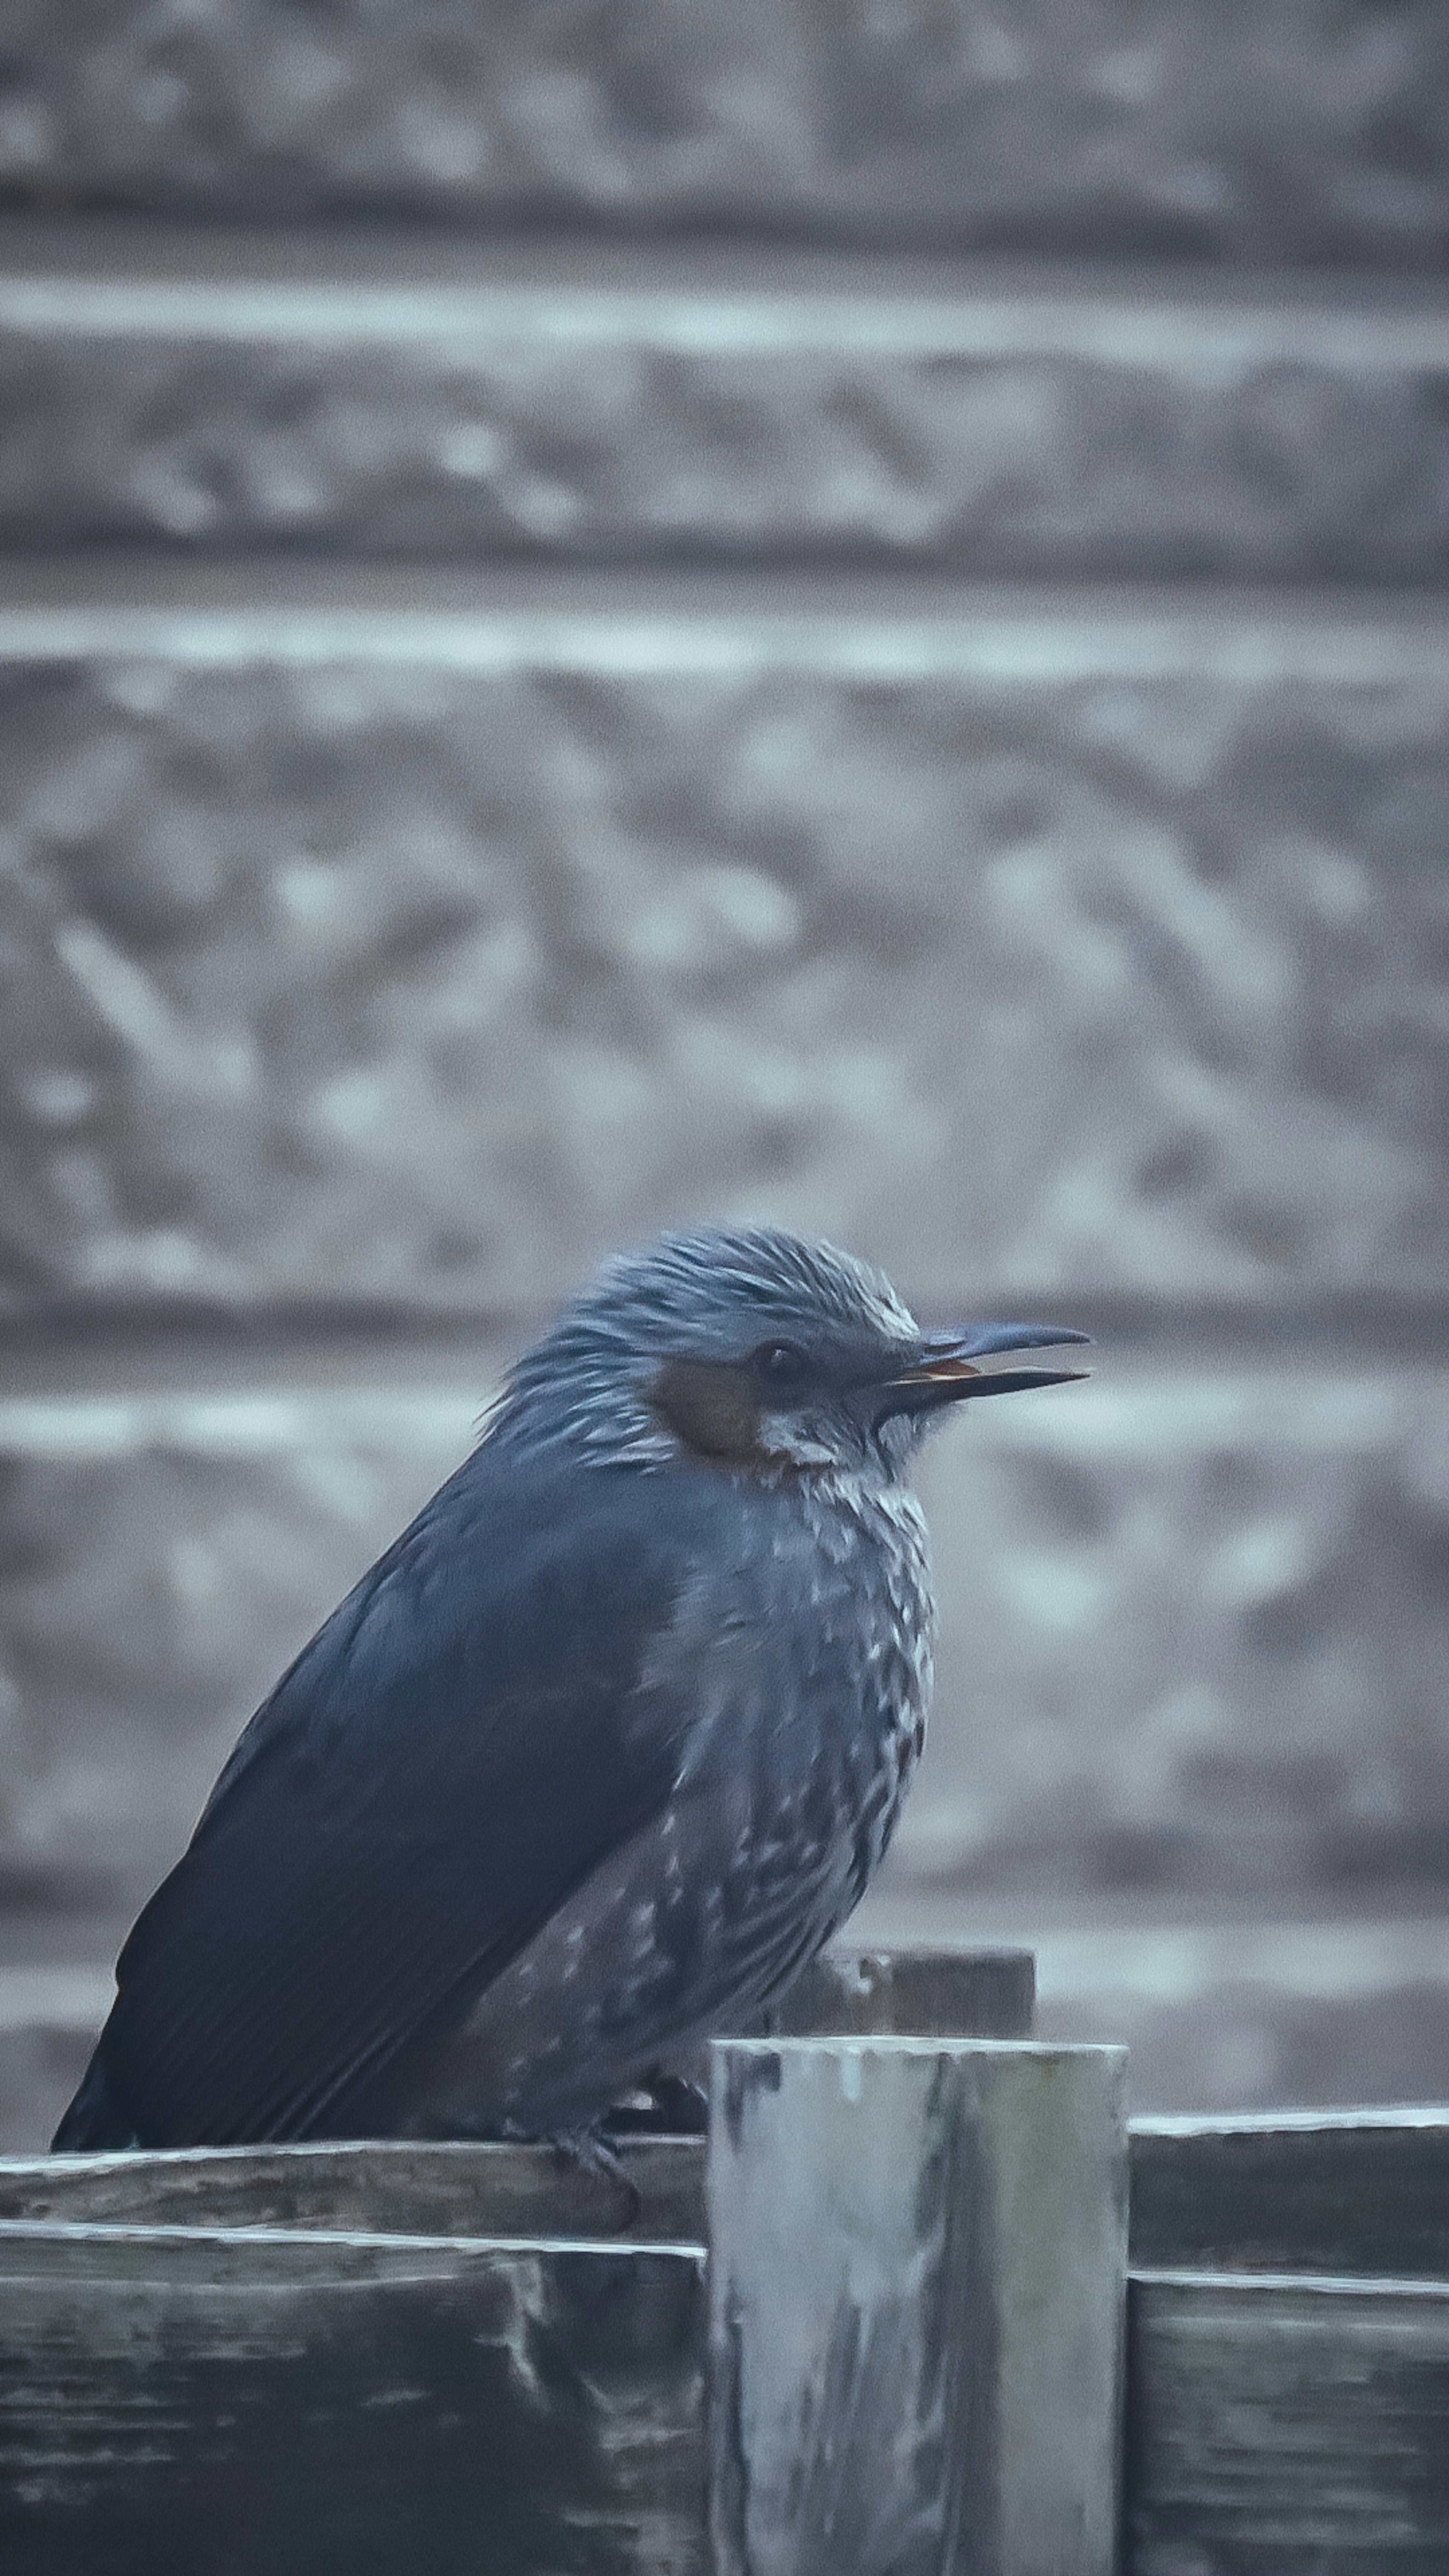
[0,1953,1449,2576]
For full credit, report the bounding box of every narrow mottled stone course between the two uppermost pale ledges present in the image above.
[0,319,1449,582]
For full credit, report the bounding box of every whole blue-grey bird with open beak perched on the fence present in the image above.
[54,1231,1086,2151]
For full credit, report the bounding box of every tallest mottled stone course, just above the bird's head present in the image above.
[0,634,1449,1309]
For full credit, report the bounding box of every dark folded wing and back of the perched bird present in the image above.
[89,1443,691,2146]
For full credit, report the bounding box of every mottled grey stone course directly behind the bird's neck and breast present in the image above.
[0,1358,1449,1929]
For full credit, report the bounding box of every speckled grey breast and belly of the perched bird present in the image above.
[402,1479,933,2136]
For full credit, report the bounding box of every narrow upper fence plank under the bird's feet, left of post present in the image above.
[0,2138,704,2244]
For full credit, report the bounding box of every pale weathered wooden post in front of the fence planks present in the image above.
[706,2038,1127,2576]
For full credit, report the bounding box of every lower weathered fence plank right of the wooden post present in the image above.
[1127,2272,1449,2576]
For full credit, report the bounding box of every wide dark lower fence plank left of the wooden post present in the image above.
[0,2226,704,2576]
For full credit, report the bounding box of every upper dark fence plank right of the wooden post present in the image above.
[1132,2110,1449,2280]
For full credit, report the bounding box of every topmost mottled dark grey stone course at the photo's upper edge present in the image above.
[0,0,1449,260]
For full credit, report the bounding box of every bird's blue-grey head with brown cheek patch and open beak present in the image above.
[495,1231,1088,1479]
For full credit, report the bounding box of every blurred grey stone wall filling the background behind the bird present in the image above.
[0,0,1449,2146]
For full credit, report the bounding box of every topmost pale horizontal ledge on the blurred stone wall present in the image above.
[0,219,1449,384]
